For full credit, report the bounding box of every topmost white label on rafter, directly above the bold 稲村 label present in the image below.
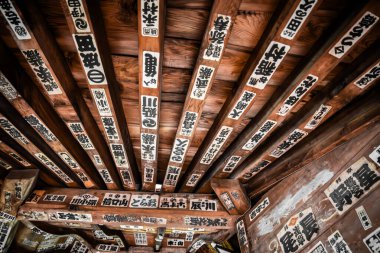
[281,0,317,40]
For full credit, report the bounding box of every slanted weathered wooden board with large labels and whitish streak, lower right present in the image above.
[241,119,380,252]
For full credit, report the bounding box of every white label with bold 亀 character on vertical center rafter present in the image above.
[142,51,160,89]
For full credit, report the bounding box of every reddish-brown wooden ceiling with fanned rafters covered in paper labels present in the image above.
[0,0,380,251]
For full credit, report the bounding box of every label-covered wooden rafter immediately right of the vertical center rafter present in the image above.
[163,0,241,192]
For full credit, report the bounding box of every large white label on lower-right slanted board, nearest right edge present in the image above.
[325,157,380,215]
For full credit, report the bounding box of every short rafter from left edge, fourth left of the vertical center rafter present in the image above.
[0,112,81,187]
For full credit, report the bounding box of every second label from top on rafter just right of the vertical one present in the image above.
[190,65,215,100]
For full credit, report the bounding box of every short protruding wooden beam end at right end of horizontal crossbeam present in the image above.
[211,178,251,215]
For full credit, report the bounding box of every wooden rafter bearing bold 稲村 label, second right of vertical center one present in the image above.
[178,0,319,192]
